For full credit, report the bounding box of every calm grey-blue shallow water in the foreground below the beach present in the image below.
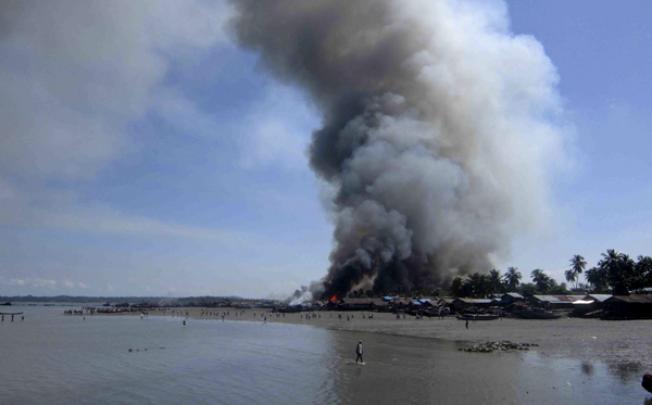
[0,306,646,404]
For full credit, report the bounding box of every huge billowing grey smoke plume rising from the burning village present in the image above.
[233,0,561,295]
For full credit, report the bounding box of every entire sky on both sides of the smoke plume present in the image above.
[0,0,652,297]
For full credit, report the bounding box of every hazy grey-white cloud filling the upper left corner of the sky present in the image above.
[0,0,228,179]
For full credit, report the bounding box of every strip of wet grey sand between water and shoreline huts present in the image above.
[150,308,652,366]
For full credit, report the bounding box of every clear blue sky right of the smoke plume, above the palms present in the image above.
[509,0,652,279]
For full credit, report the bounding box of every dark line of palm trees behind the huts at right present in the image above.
[449,249,652,297]
